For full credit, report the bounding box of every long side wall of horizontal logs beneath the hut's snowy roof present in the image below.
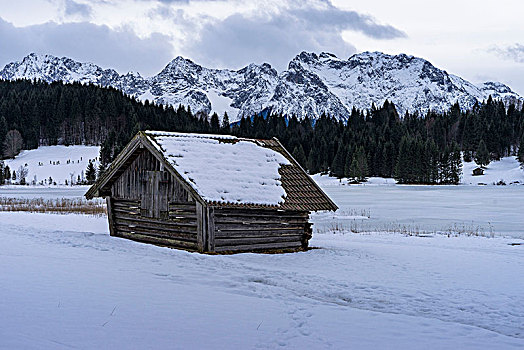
[212,208,310,252]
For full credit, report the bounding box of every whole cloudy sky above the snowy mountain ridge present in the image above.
[0,0,524,95]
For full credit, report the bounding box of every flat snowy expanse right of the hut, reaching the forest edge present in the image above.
[313,157,524,239]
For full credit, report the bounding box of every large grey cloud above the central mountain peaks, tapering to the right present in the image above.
[186,2,406,70]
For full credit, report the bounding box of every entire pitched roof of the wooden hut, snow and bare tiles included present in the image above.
[86,131,337,212]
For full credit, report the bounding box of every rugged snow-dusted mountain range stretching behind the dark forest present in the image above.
[0,52,524,121]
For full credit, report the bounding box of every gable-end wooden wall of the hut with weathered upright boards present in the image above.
[109,151,203,250]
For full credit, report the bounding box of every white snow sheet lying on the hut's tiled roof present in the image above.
[145,131,291,206]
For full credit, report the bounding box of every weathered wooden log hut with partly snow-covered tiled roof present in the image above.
[85,131,337,253]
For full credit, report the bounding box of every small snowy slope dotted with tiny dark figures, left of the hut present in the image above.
[4,146,100,184]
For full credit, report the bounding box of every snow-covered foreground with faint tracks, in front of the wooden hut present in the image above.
[0,213,524,349]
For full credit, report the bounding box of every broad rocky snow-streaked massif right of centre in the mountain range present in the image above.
[294,52,485,114]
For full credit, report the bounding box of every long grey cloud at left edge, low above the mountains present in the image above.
[0,18,173,75]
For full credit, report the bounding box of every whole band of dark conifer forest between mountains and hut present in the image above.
[0,80,524,184]
